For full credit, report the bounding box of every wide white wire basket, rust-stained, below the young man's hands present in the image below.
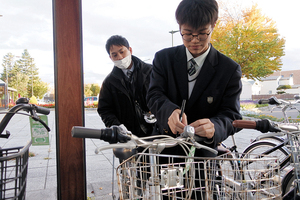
[117,153,281,200]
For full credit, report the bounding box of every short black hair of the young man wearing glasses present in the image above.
[175,0,219,29]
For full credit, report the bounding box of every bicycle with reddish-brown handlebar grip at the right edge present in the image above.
[233,120,300,199]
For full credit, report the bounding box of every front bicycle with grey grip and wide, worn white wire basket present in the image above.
[72,126,281,199]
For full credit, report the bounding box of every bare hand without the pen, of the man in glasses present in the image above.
[190,119,215,139]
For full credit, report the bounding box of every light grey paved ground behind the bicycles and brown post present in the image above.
[0,109,272,200]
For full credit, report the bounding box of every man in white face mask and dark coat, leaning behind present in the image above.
[97,35,152,137]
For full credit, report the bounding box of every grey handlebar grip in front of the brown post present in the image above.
[71,126,101,139]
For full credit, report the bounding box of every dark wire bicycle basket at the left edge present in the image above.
[0,141,31,200]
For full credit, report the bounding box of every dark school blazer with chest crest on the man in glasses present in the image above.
[147,45,242,152]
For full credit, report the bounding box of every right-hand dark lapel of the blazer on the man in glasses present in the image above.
[186,46,217,109]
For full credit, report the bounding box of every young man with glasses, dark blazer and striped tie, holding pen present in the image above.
[147,0,242,156]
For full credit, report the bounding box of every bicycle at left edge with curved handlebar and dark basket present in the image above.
[0,98,50,200]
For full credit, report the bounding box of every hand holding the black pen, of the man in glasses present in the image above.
[168,109,187,134]
